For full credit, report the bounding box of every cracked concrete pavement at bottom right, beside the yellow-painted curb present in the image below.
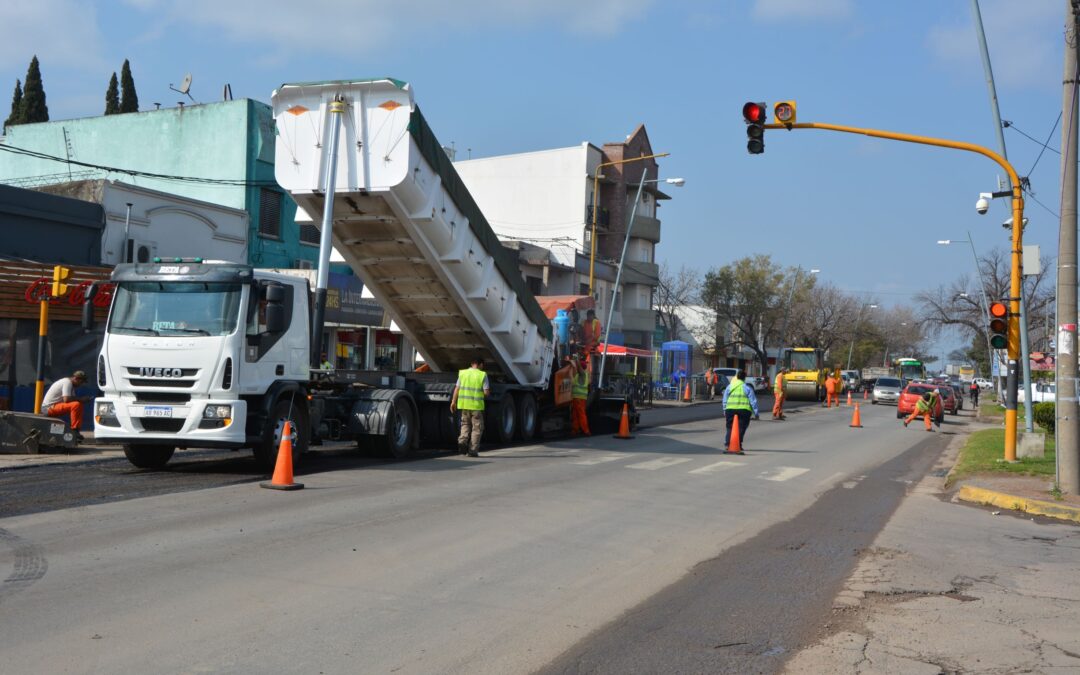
[785,436,1080,674]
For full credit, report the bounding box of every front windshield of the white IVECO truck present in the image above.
[109,282,241,335]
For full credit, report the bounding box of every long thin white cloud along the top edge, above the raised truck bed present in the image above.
[126,0,656,55]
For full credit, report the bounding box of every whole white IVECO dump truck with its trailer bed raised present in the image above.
[90,79,636,468]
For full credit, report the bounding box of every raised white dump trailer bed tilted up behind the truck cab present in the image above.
[272,79,555,389]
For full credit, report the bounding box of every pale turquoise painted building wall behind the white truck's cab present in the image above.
[0,98,319,267]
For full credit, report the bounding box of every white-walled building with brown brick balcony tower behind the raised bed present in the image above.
[455,125,670,350]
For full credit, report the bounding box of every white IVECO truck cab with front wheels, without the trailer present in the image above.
[84,258,310,468]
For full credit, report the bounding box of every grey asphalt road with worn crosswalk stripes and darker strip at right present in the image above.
[0,397,957,673]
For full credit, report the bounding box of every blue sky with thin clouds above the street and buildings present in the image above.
[0,0,1064,358]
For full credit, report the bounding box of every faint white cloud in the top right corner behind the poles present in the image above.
[927,0,1064,86]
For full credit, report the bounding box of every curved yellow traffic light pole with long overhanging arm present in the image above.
[765,118,1024,462]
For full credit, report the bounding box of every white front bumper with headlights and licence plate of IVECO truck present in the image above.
[92,396,247,448]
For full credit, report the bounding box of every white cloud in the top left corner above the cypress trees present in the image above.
[0,0,104,72]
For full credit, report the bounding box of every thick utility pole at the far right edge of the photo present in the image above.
[1054,0,1080,495]
